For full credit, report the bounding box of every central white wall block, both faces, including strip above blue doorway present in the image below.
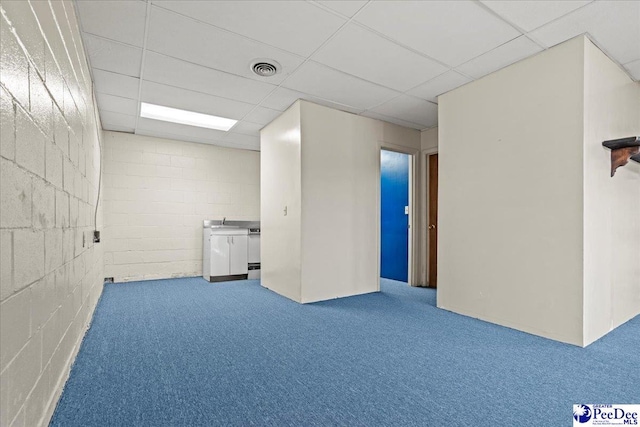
[261,101,420,303]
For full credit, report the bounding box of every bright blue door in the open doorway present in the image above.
[380,150,409,282]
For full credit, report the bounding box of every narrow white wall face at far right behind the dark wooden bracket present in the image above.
[584,41,640,345]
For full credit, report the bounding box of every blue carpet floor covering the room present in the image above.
[51,278,640,427]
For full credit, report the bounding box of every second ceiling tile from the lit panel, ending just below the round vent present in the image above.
[143,52,275,104]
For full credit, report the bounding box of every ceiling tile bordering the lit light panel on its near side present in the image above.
[140,81,254,120]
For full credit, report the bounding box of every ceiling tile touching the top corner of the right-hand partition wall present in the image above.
[530,1,640,64]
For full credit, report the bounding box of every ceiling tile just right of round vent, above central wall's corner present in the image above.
[284,61,398,109]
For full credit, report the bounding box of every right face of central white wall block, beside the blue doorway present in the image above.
[301,102,382,302]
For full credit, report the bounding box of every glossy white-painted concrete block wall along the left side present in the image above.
[0,0,104,426]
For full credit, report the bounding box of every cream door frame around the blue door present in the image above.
[376,145,422,291]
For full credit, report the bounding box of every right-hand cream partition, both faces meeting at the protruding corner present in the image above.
[438,37,640,346]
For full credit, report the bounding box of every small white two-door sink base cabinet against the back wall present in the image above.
[202,228,248,282]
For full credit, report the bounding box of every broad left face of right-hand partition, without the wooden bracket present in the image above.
[438,38,584,345]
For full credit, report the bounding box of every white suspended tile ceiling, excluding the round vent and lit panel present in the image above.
[76,0,640,150]
